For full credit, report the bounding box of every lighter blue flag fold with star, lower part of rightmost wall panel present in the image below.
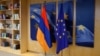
[76,25,94,47]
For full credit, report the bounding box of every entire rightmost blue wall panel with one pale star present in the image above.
[76,0,95,47]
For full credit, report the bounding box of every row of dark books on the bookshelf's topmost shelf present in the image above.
[0,3,20,10]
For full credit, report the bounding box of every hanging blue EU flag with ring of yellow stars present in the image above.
[55,3,68,54]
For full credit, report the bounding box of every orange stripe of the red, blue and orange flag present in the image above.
[37,27,49,52]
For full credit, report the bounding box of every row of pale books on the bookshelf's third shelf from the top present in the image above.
[0,23,20,30]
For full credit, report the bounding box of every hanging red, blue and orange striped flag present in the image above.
[37,5,52,52]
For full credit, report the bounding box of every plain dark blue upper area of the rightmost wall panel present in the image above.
[76,0,95,33]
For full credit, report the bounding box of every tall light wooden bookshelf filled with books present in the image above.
[0,0,27,54]
